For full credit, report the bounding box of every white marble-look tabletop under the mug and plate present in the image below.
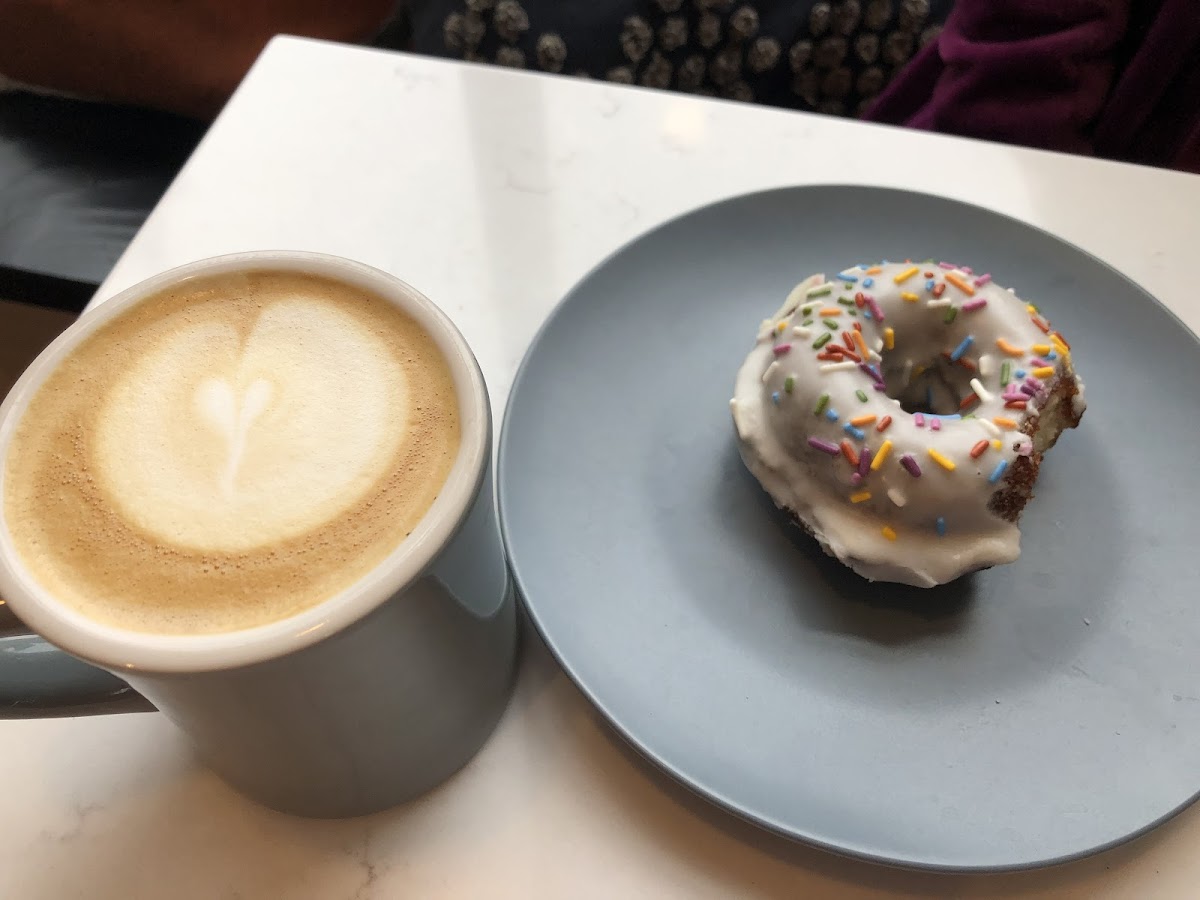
[0,38,1200,900]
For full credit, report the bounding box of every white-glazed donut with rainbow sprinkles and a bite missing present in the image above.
[730,262,1085,587]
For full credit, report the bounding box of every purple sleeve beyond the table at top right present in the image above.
[865,0,1129,154]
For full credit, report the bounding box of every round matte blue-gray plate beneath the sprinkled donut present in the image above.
[498,187,1200,870]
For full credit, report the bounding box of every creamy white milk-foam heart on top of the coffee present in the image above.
[92,296,408,552]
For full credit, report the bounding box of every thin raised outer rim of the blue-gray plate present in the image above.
[496,182,1200,875]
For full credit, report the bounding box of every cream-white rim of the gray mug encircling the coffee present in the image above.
[0,250,492,673]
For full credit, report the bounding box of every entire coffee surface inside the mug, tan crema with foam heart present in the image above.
[4,269,460,635]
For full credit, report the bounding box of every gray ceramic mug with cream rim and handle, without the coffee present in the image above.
[0,251,516,816]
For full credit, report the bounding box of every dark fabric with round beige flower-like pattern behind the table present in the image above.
[406,0,953,115]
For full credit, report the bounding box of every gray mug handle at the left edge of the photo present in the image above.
[0,635,154,719]
